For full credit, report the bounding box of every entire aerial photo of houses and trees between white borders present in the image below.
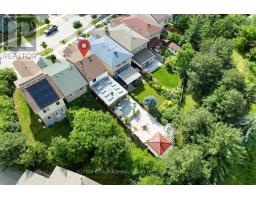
[0,14,256,185]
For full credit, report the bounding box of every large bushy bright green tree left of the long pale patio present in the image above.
[69,109,129,170]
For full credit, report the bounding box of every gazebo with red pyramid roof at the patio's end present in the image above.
[148,132,171,156]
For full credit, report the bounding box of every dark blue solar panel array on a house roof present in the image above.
[27,79,59,109]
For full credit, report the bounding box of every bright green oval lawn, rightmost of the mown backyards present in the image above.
[152,67,180,88]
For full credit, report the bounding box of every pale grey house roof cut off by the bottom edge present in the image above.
[16,166,99,185]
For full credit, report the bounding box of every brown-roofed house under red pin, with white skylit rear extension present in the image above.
[64,46,128,107]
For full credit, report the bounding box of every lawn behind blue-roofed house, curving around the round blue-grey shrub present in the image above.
[131,82,165,109]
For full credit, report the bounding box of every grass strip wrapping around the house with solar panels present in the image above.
[13,89,71,145]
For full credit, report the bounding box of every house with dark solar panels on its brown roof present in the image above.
[13,60,66,126]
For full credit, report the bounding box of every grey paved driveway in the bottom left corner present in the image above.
[0,170,22,185]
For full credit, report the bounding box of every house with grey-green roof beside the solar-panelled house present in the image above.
[38,58,87,103]
